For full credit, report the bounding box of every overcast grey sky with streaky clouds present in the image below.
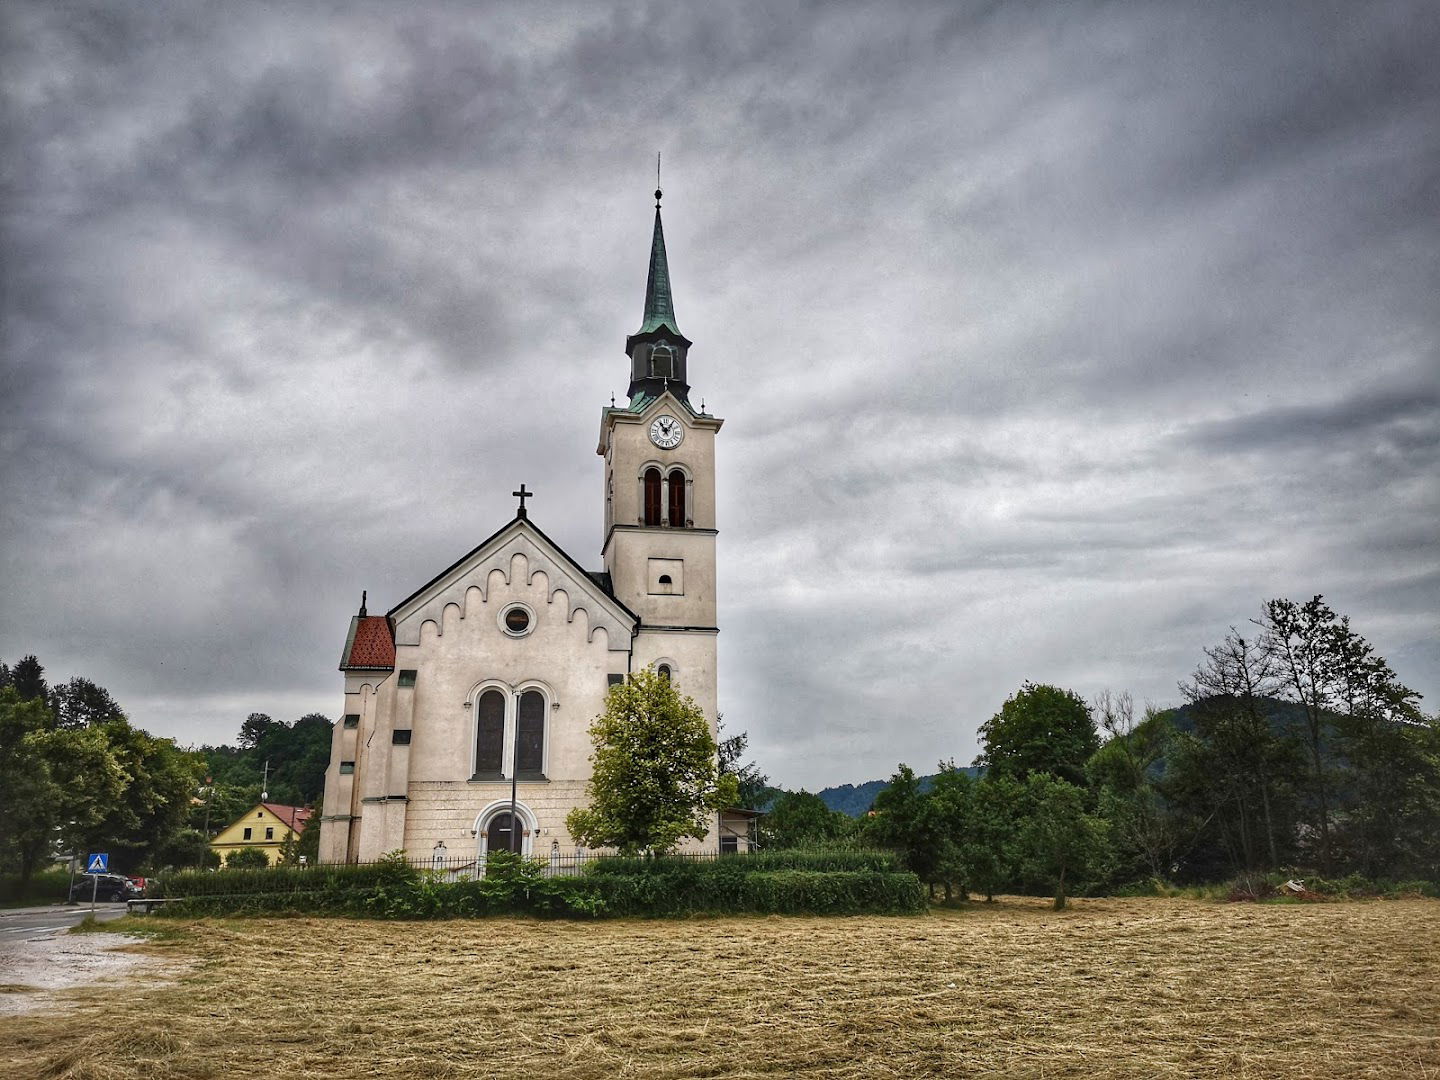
[0,0,1440,789]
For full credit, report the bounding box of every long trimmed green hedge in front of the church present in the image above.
[157,855,924,919]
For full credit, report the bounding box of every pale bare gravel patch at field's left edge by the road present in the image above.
[0,933,185,1015]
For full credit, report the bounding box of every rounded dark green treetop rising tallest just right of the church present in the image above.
[975,683,1100,785]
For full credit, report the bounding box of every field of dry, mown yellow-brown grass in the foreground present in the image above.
[0,899,1440,1080]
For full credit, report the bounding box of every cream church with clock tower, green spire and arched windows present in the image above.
[320,190,749,863]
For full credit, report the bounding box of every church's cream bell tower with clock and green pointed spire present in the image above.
[598,189,723,724]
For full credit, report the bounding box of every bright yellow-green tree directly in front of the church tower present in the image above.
[564,671,739,854]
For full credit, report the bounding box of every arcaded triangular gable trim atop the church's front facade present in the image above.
[389,517,638,652]
